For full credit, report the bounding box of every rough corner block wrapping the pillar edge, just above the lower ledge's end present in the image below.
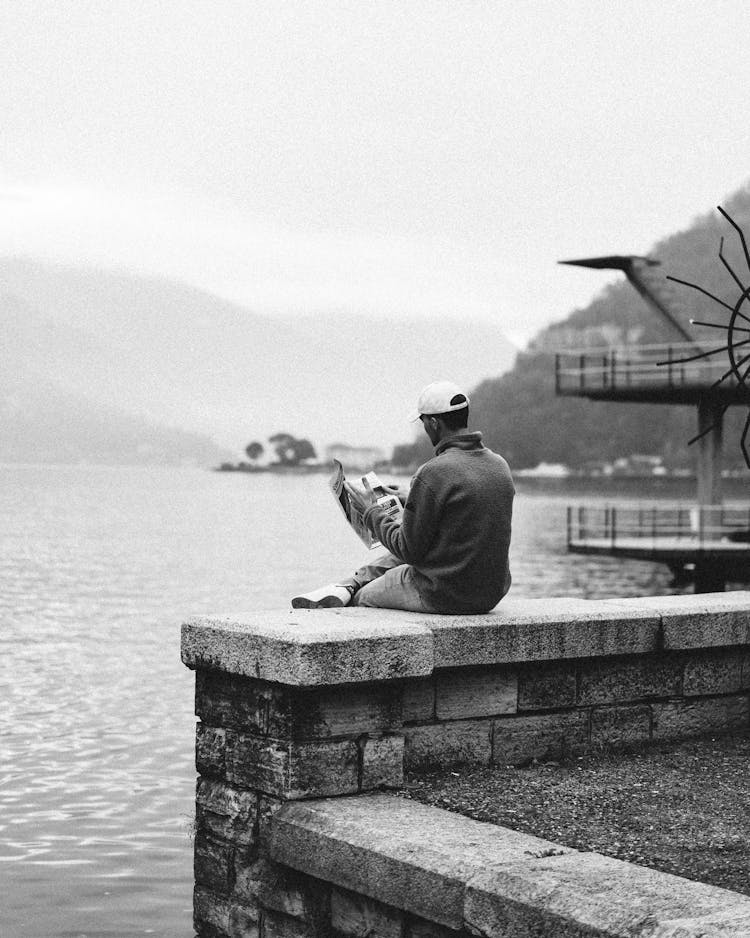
[227,733,359,799]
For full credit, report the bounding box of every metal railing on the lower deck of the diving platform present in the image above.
[567,504,750,550]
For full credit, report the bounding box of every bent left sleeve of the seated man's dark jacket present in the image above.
[365,476,438,564]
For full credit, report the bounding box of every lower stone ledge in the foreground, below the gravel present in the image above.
[270,795,750,938]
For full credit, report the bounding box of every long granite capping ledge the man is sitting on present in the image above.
[182,591,750,686]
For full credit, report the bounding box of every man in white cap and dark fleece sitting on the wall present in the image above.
[292,381,515,613]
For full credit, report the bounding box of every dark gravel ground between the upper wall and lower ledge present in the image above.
[401,731,750,895]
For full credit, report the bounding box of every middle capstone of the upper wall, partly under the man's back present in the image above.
[422,597,660,668]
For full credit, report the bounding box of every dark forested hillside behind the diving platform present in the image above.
[471,185,750,469]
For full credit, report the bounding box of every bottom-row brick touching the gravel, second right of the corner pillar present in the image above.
[492,710,589,765]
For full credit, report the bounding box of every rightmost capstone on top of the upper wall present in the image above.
[607,590,750,651]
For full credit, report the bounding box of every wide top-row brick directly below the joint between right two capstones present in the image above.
[578,654,682,705]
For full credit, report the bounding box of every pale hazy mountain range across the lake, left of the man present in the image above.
[0,258,515,459]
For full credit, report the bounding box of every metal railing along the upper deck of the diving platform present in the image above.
[555,342,735,394]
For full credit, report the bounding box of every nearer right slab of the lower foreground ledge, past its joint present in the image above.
[466,853,750,938]
